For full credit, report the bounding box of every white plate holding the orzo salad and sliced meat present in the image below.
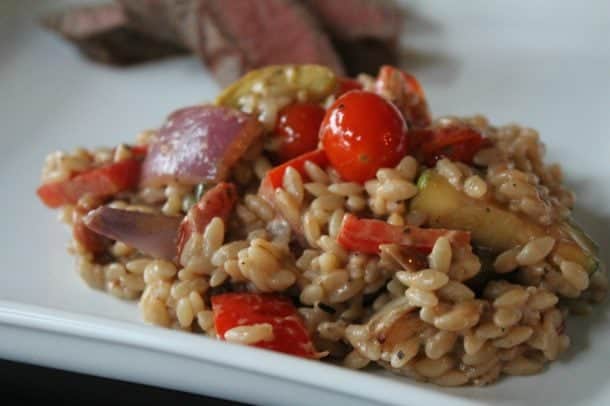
[0,0,610,405]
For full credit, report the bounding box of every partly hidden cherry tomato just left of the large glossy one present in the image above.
[275,103,324,162]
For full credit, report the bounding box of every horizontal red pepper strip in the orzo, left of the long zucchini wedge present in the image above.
[337,214,470,254]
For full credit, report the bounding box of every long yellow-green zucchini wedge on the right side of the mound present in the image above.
[411,170,599,273]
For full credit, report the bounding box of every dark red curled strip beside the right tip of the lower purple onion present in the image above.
[178,182,237,259]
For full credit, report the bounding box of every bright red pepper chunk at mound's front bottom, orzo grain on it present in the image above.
[212,293,316,358]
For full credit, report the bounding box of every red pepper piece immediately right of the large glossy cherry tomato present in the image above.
[411,125,485,166]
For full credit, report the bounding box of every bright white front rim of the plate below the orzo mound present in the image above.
[0,300,480,405]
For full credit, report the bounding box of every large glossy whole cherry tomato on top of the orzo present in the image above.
[320,90,409,182]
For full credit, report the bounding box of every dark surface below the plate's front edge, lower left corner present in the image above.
[0,360,244,406]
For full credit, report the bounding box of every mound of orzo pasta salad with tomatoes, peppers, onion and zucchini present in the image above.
[37,65,608,386]
